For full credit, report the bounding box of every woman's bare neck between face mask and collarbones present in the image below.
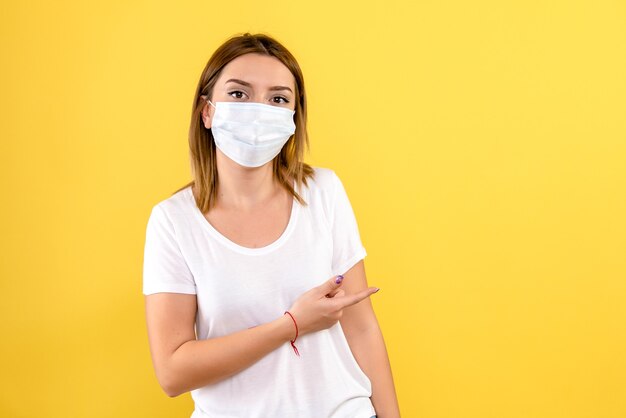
[216,150,281,210]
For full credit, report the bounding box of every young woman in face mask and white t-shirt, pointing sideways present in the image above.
[143,34,399,418]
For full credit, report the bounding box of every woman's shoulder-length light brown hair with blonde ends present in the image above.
[179,33,313,213]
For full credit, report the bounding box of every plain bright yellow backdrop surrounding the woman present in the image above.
[0,0,626,418]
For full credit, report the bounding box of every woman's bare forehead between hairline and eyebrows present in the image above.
[217,54,295,90]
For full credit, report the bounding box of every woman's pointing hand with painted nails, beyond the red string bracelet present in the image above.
[289,276,378,335]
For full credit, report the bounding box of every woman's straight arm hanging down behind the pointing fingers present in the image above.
[340,260,400,418]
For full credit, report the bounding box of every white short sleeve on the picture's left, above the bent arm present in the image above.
[143,205,196,295]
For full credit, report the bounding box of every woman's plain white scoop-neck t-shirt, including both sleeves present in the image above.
[143,168,375,418]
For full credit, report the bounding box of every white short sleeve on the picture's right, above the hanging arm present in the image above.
[331,172,367,275]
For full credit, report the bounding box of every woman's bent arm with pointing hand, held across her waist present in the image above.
[145,277,376,397]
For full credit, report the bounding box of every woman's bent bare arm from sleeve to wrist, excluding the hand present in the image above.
[146,293,294,396]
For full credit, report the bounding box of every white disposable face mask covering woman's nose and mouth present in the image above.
[208,100,296,167]
